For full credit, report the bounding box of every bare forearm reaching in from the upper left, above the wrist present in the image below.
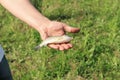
[0,0,50,31]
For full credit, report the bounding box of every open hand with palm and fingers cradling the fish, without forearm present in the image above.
[40,21,80,50]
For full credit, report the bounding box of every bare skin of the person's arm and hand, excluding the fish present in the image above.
[0,0,80,50]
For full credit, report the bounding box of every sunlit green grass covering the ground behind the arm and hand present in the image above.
[0,0,120,80]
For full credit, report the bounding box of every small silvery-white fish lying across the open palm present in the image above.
[35,35,73,50]
